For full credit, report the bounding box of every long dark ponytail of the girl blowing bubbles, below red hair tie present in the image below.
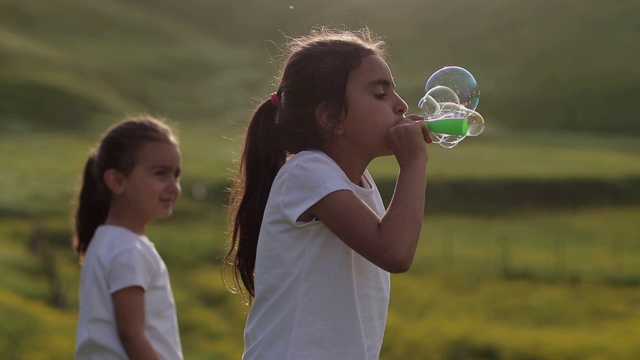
[223,100,287,300]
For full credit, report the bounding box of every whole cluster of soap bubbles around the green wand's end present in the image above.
[418,66,484,148]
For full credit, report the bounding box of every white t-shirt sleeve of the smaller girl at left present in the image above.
[107,244,154,294]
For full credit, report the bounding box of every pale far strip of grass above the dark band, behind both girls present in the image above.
[0,124,640,219]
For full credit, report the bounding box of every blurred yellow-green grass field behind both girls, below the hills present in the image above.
[0,124,640,359]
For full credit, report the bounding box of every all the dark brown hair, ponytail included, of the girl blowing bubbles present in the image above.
[223,28,384,301]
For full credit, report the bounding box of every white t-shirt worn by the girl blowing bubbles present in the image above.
[243,151,390,360]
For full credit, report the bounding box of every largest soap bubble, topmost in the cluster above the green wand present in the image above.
[424,66,480,110]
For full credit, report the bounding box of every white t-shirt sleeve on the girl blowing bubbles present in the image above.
[281,154,352,224]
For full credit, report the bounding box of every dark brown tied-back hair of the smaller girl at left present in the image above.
[73,116,178,261]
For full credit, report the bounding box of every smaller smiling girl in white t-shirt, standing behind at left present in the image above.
[74,117,182,360]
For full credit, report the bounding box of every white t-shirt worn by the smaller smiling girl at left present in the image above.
[75,225,183,360]
